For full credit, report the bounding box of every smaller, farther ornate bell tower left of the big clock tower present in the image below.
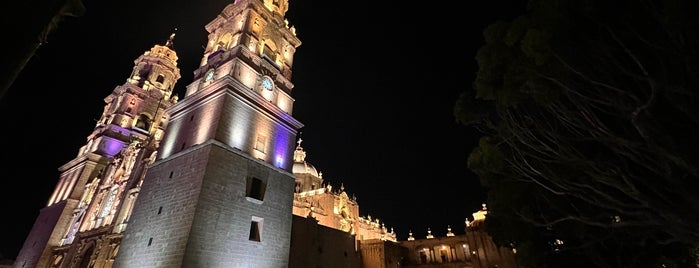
[15,34,180,267]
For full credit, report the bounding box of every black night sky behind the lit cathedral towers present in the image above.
[0,0,525,258]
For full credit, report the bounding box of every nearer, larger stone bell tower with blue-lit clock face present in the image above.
[114,0,303,267]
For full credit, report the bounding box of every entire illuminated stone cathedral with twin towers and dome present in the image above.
[12,0,516,268]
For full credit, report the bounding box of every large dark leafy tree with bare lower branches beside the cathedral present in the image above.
[454,0,699,267]
